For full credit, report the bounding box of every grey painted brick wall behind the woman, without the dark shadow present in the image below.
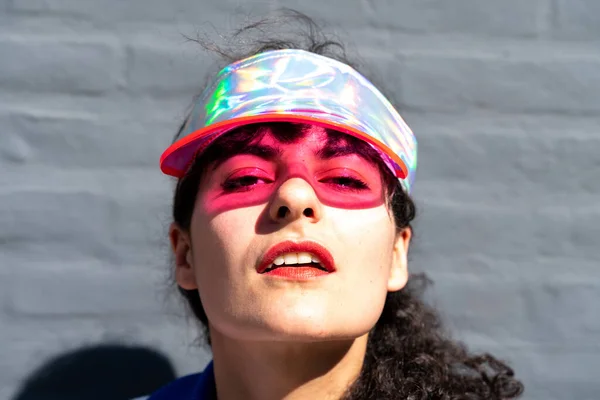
[0,0,600,400]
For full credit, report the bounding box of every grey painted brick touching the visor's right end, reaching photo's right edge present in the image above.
[402,110,600,208]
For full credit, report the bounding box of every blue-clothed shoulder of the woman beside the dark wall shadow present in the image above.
[147,362,215,400]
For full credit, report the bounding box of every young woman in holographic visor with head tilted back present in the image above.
[150,13,523,400]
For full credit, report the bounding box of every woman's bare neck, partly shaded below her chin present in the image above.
[211,329,367,400]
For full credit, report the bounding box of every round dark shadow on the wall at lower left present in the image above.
[13,344,175,400]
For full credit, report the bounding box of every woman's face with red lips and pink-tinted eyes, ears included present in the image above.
[171,126,410,341]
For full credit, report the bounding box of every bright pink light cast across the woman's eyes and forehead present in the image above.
[199,129,384,215]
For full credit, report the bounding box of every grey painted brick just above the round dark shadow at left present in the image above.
[9,262,162,317]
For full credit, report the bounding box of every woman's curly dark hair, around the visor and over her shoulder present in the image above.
[173,10,523,400]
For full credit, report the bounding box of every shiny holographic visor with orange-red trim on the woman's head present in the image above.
[160,50,417,192]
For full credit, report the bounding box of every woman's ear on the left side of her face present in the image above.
[169,223,198,290]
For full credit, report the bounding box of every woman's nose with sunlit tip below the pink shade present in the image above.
[269,178,322,222]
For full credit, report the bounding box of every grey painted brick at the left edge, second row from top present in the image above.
[0,38,122,94]
